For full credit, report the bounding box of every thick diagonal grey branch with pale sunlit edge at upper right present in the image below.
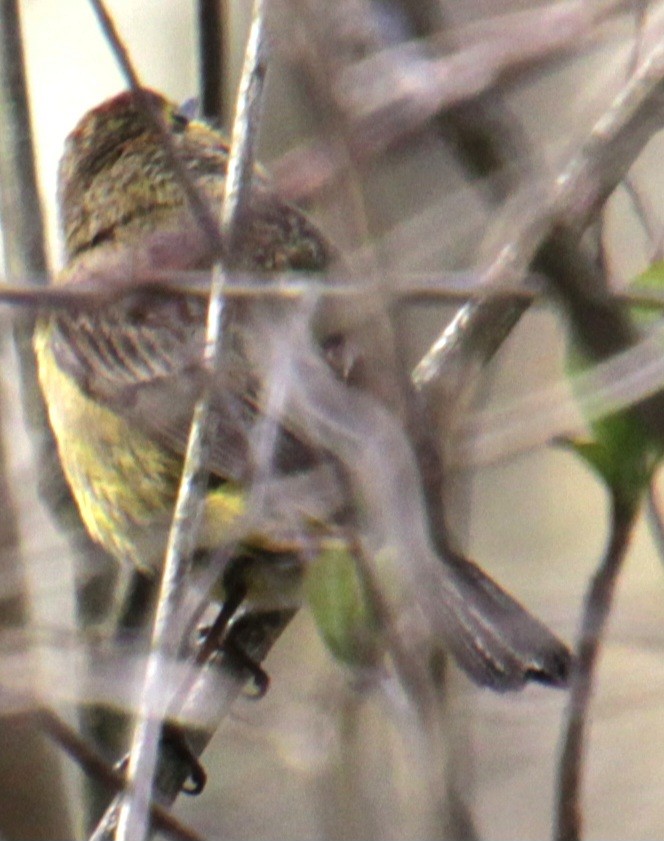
[413,30,664,440]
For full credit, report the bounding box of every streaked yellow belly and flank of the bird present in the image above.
[34,318,246,572]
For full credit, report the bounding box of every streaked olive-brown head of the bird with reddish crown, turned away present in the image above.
[58,91,228,258]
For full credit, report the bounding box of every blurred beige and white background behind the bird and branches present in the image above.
[0,0,664,839]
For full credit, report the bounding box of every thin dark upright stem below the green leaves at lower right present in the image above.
[554,494,638,841]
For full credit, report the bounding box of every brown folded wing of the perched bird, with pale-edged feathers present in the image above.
[50,290,315,481]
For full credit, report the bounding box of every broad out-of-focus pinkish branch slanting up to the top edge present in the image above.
[333,0,624,156]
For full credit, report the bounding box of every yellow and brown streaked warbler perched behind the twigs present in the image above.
[34,92,570,689]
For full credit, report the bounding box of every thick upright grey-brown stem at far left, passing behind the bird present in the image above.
[0,0,126,834]
